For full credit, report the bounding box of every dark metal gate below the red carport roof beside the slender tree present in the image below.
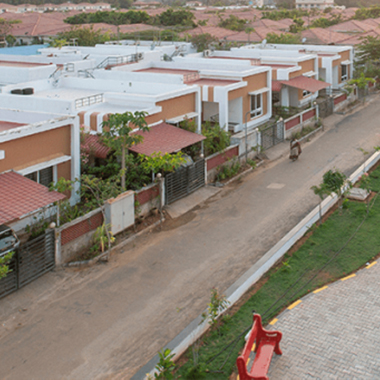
[165,159,206,205]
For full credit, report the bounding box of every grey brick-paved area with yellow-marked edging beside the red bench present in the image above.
[268,264,380,380]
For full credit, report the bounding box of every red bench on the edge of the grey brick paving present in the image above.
[236,314,282,380]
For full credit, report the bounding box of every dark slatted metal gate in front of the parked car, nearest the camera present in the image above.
[0,229,55,298]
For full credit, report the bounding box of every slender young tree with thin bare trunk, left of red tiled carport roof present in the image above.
[102,111,149,191]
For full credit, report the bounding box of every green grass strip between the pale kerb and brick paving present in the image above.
[176,168,380,379]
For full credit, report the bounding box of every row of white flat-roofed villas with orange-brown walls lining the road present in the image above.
[0,42,353,230]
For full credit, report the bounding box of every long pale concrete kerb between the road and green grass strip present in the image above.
[131,152,380,380]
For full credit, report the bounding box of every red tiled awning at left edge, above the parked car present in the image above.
[0,172,66,224]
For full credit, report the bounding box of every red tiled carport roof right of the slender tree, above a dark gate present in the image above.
[130,123,206,156]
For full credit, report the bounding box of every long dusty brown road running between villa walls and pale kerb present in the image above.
[0,95,380,380]
